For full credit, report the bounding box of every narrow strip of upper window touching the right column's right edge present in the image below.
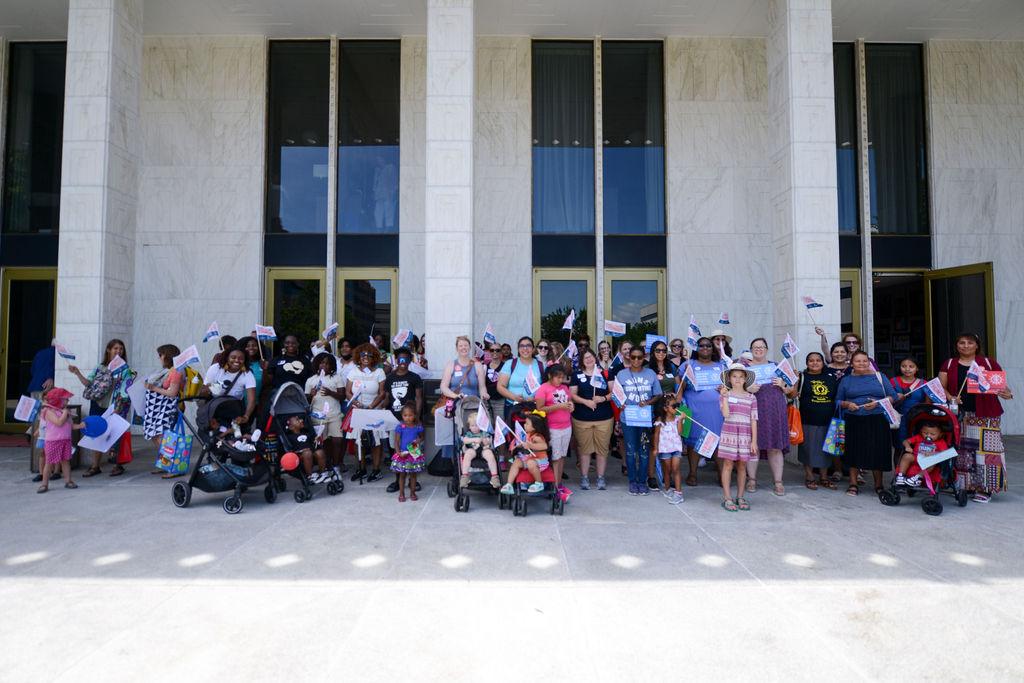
[833,43,860,233]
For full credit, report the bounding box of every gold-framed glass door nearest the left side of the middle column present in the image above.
[335,268,397,350]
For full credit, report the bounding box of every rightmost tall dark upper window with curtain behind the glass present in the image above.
[864,44,929,234]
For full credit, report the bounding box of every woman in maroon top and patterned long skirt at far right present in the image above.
[939,332,1014,503]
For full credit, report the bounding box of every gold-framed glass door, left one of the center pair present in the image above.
[534,268,595,344]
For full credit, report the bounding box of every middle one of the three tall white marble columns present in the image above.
[424,0,477,368]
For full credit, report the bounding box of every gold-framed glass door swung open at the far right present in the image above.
[925,263,995,377]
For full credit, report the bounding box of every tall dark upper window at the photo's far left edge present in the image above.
[3,43,67,233]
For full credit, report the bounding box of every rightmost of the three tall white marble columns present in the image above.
[768,0,840,366]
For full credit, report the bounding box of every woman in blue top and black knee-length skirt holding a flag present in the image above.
[836,351,898,496]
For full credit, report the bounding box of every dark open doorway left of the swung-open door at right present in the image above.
[871,272,928,377]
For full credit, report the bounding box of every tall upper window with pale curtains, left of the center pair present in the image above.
[532,41,594,233]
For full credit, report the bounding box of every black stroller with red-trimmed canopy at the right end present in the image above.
[879,403,969,515]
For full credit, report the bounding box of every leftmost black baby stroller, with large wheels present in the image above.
[171,396,278,515]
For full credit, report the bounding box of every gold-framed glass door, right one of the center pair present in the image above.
[602,268,666,345]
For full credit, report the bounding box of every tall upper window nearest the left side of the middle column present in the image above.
[338,40,401,233]
